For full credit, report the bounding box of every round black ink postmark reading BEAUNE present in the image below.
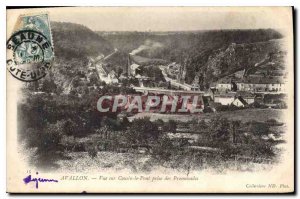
[6,30,54,82]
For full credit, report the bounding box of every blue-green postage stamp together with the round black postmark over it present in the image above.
[6,14,54,82]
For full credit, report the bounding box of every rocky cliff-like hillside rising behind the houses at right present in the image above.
[205,40,284,83]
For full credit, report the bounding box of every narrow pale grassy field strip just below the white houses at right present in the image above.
[130,109,286,122]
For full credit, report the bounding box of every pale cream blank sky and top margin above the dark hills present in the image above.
[7,7,291,31]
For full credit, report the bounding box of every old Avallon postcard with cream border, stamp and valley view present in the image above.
[6,7,294,193]
